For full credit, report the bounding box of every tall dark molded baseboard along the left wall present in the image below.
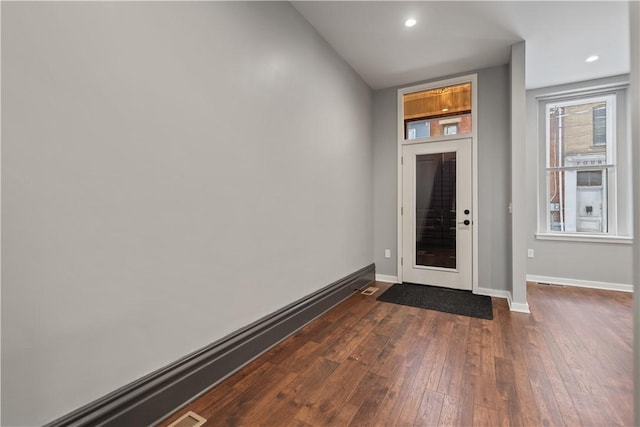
[46,264,375,427]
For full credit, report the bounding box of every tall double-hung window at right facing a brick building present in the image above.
[541,91,630,236]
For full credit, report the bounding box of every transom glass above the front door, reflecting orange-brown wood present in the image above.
[403,83,471,140]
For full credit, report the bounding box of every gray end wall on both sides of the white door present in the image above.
[373,65,511,290]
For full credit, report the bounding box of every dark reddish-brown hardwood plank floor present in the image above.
[161,282,633,426]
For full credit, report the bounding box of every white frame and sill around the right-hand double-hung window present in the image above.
[536,86,633,244]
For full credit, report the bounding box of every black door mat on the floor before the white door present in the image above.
[377,283,493,320]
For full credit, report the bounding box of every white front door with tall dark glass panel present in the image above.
[402,138,473,290]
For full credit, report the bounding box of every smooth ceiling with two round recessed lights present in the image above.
[292,1,630,89]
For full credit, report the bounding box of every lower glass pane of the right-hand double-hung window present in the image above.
[547,169,607,233]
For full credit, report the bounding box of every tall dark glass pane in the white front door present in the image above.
[416,152,456,268]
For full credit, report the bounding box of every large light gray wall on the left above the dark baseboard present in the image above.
[2,2,373,425]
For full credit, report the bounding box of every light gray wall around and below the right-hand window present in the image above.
[526,76,633,285]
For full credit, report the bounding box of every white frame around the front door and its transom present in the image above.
[396,74,479,294]
